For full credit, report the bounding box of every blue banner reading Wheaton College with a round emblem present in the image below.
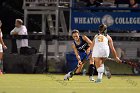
[71,11,140,31]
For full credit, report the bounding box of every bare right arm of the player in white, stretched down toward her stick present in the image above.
[107,35,121,62]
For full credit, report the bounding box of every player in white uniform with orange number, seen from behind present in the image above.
[91,24,121,83]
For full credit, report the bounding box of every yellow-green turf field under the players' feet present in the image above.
[0,74,140,93]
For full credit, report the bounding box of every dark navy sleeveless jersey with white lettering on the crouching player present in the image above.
[74,36,89,52]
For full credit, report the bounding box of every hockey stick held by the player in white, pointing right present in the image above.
[107,58,140,69]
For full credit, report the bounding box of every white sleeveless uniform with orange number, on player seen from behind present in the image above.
[92,34,110,57]
